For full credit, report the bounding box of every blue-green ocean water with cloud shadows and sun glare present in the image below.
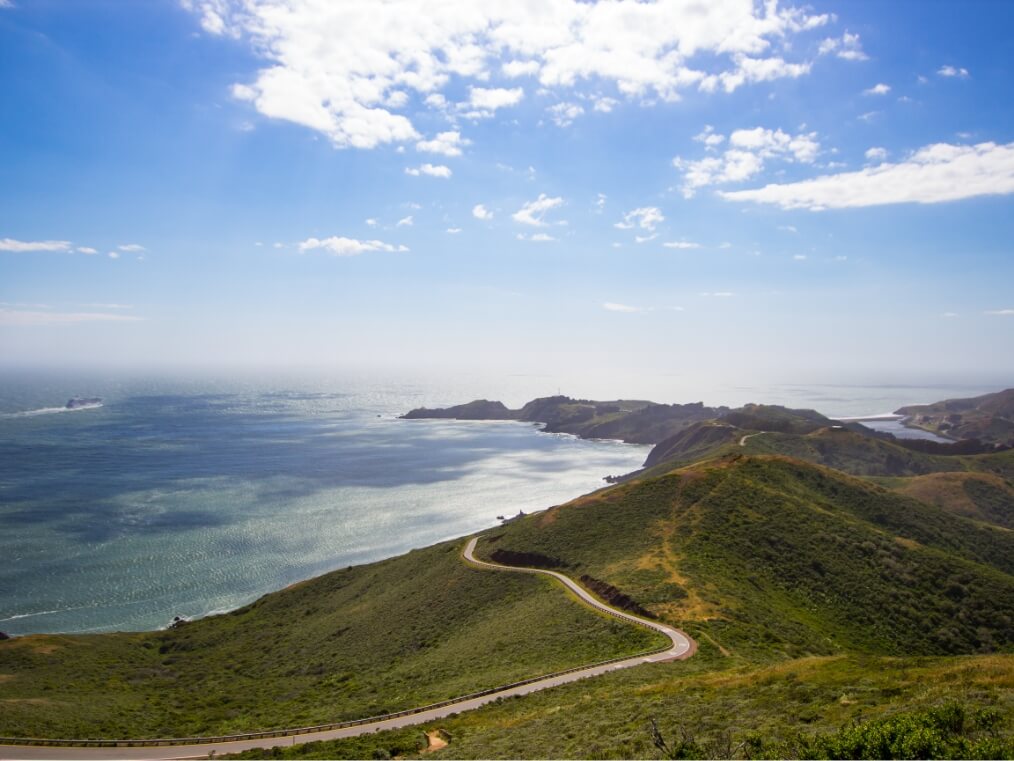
[0,373,991,634]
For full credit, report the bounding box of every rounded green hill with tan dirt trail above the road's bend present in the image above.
[480,456,1014,660]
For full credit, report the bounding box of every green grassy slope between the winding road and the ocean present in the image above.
[0,542,665,738]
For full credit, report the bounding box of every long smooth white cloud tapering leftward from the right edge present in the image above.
[719,143,1014,211]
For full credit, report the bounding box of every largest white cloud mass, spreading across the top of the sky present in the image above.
[190,0,831,148]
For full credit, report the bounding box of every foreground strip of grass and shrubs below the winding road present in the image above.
[224,647,1014,759]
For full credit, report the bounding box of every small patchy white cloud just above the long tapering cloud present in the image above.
[672,127,820,198]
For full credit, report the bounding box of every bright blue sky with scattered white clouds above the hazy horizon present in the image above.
[0,0,1014,386]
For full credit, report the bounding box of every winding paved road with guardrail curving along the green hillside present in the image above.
[0,538,697,761]
